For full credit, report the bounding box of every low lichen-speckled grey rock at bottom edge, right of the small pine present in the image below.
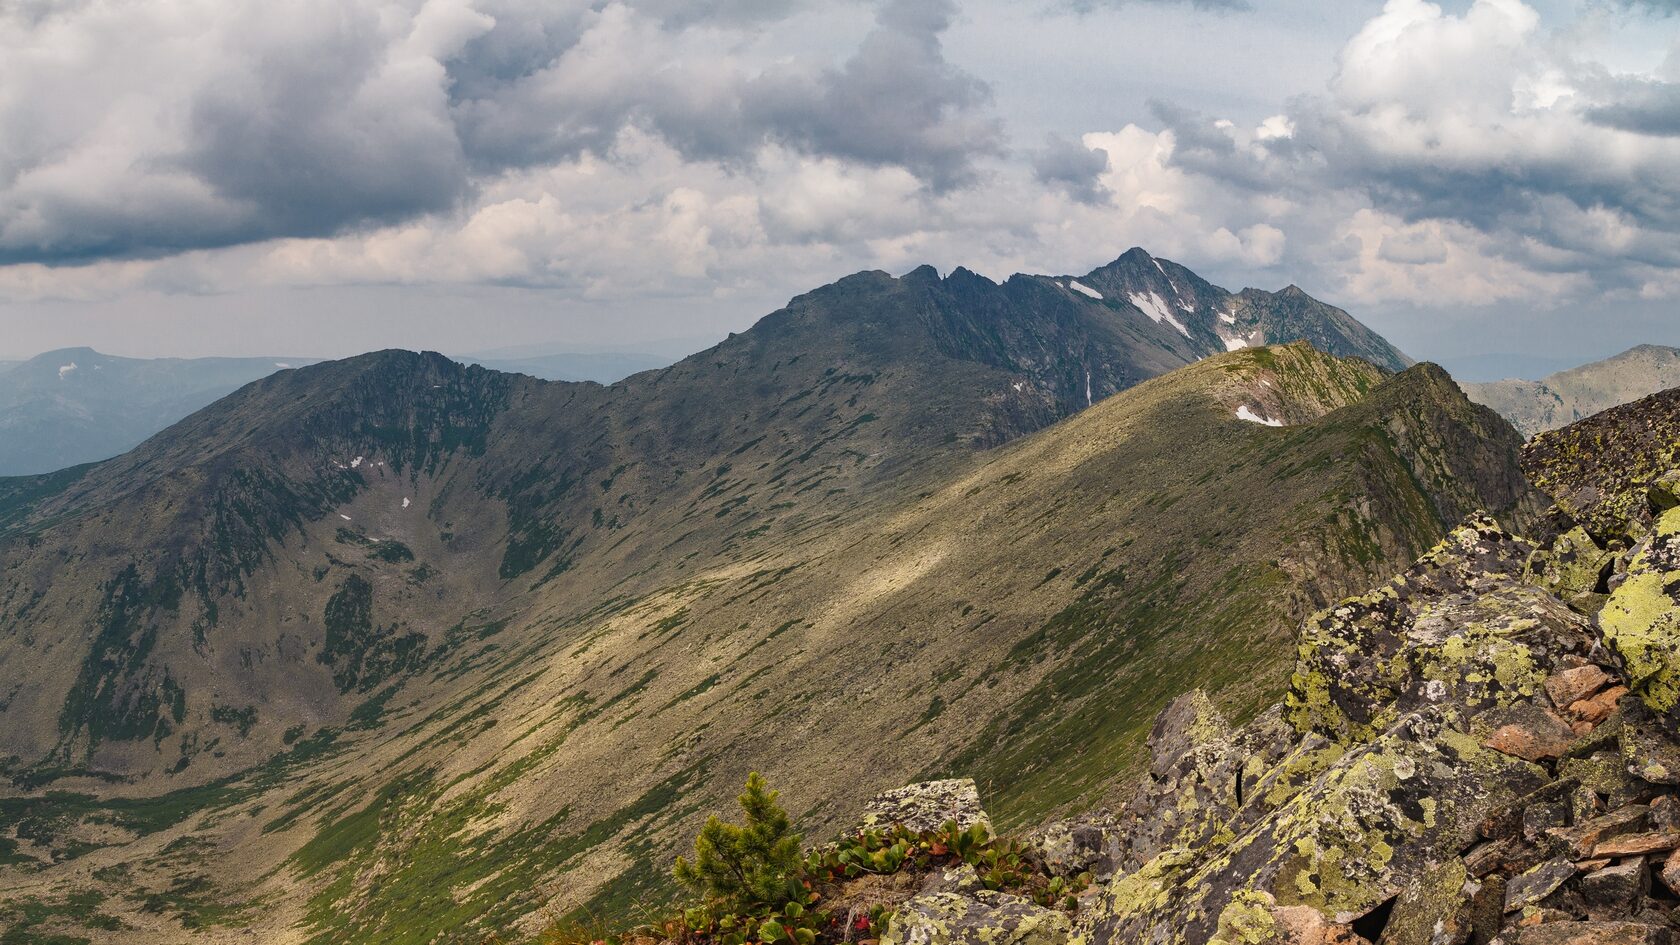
[880,891,1074,945]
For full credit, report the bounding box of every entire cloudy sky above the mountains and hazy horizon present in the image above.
[0,0,1680,374]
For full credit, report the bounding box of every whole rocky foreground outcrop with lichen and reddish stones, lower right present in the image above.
[882,399,1680,945]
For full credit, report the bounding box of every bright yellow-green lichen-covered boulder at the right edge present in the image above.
[1599,508,1680,713]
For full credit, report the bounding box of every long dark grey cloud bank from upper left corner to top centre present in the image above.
[0,0,1001,264]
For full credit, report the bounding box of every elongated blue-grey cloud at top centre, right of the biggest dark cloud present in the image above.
[450,0,1001,188]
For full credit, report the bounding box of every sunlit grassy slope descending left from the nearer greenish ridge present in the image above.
[0,348,1538,942]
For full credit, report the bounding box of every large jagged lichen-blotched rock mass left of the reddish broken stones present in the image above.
[1080,518,1598,945]
